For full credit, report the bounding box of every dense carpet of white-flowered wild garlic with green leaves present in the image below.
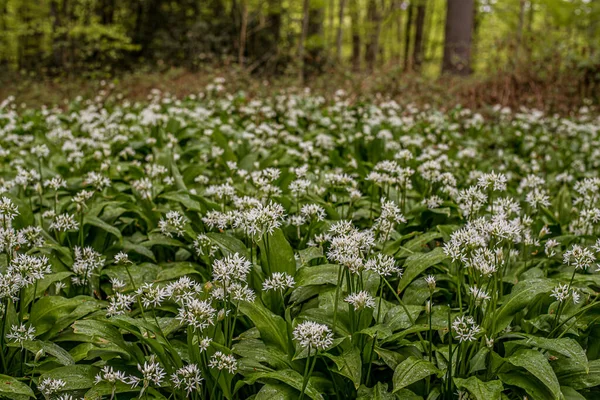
[0,85,600,400]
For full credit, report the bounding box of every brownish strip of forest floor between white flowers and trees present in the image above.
[0,67,599,114]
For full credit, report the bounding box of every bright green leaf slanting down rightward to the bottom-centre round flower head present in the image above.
[238,301,293,353]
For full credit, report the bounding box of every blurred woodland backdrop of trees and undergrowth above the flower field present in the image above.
[0,0,600,106]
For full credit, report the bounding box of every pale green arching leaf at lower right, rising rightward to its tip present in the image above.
[494,279,556,333]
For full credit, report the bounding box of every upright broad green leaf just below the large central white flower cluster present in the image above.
[258,229,296,276]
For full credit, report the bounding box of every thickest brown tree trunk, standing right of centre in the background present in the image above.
[442,0,474,75]
